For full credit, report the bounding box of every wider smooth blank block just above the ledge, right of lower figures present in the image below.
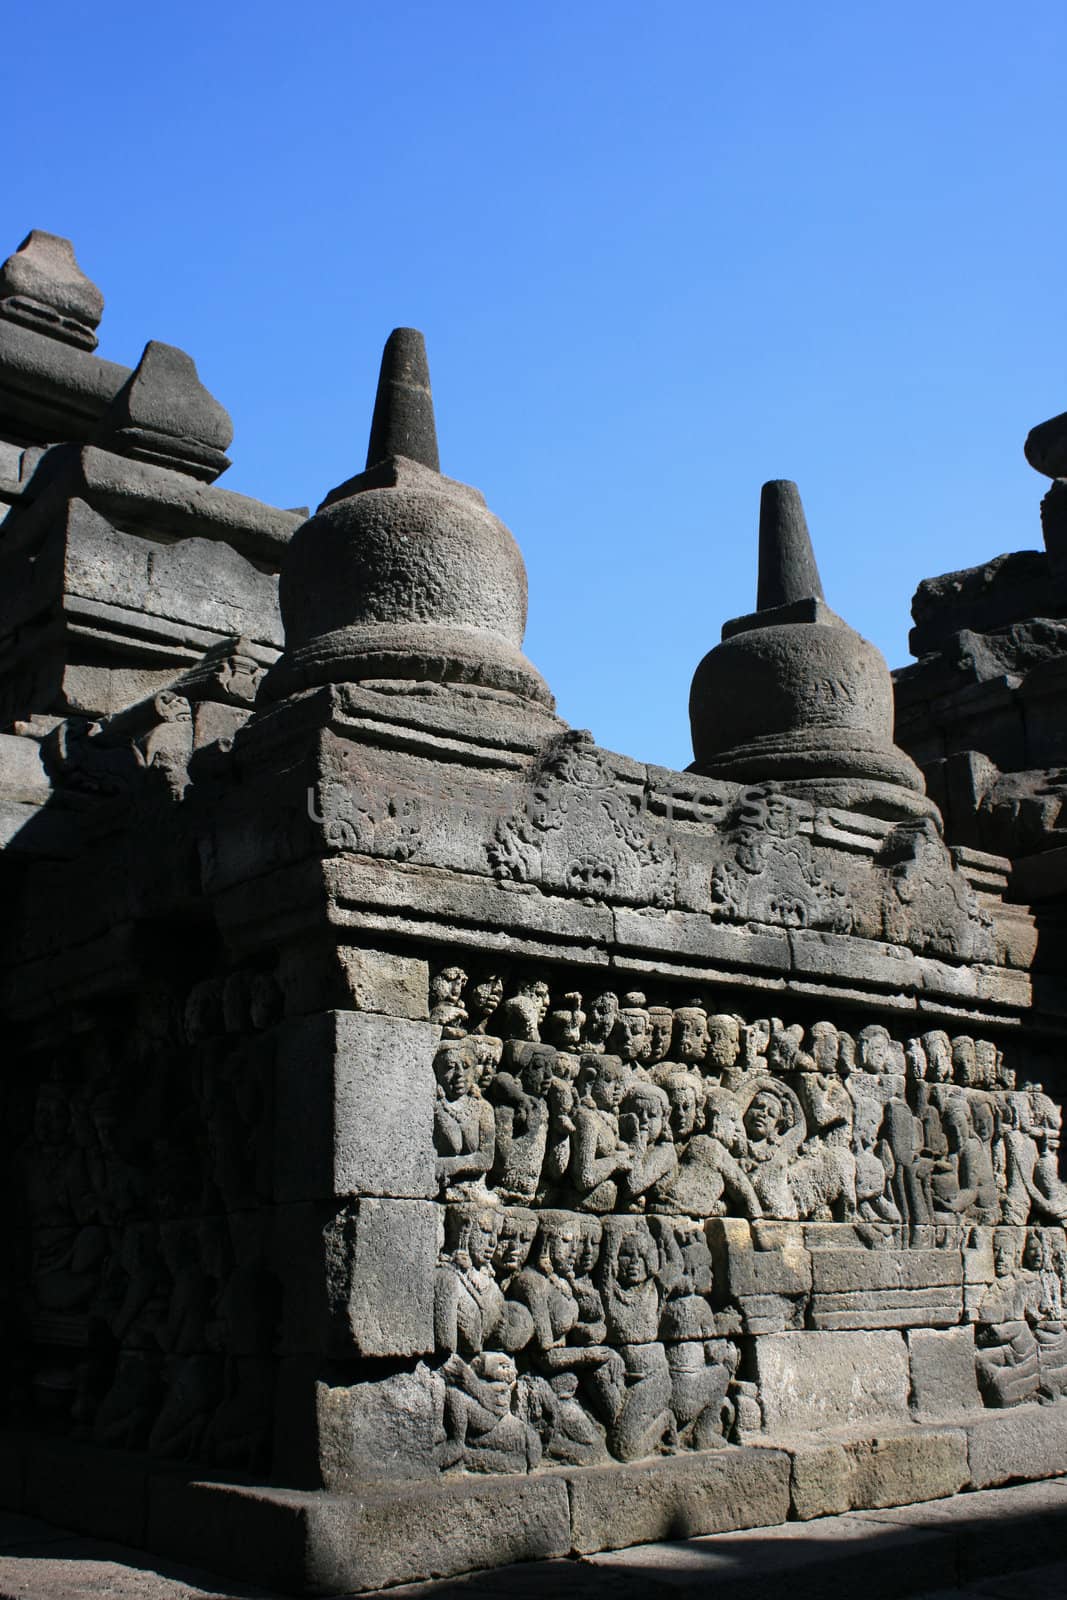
[753,1330,909,1432]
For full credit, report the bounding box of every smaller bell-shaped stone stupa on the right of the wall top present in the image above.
[689,482,934,819]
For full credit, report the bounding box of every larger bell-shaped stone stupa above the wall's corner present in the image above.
[264,328,553,712]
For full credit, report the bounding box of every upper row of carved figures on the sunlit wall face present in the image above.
[432,966,1067,1245]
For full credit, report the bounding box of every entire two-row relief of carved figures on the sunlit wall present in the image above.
[430,965,1067,1470]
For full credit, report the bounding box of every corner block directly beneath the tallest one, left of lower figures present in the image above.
[274,1198,442,1360]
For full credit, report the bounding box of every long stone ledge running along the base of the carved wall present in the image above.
[0,1402,1067,1594]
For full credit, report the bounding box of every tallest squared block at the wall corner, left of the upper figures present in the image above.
[275,1011,440,1203]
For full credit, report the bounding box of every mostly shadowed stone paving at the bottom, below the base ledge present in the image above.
[0,1478,1067,1600]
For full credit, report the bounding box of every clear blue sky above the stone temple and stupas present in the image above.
[0,0,1067,766]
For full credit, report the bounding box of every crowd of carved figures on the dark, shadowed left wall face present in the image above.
[5,973,278,1469]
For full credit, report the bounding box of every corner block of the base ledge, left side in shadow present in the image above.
[149,1474,571,1594]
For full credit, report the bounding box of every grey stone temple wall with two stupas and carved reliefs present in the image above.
[0,234,1067,1592]
